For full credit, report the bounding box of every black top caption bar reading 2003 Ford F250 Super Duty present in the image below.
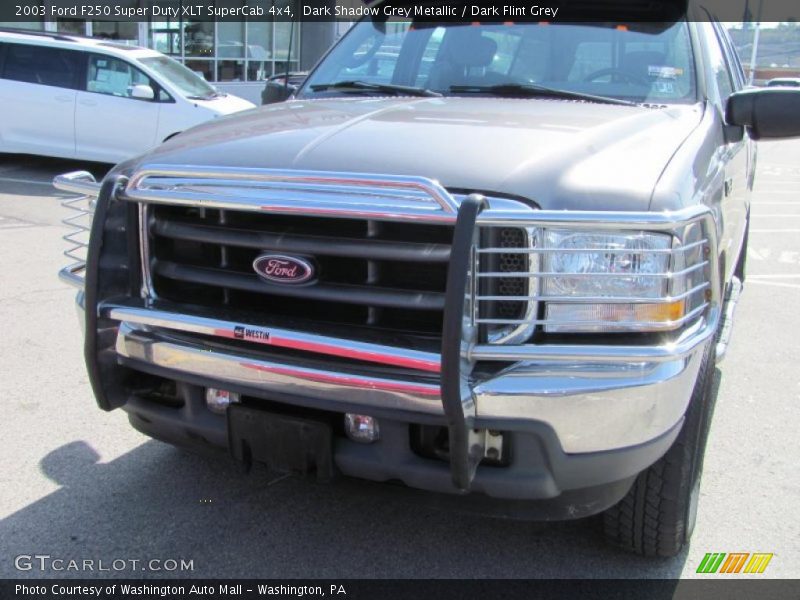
[0,0,800,24]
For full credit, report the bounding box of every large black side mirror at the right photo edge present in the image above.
[725,88,800,140]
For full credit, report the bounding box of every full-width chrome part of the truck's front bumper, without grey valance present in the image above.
[108,305,710,454]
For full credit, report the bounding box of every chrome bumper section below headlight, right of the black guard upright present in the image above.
[473,348,702,454]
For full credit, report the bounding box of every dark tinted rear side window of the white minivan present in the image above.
[3,44,81,89]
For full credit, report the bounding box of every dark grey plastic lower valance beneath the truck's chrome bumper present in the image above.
[122,370,682,520]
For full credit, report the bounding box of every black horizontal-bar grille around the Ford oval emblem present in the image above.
[149,206,453,340]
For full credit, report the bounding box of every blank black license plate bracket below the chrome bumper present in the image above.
[227,404,335,481]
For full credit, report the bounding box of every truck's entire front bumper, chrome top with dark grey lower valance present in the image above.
[89,303,710,508]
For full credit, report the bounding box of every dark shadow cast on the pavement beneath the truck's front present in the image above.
[0,434,686,578]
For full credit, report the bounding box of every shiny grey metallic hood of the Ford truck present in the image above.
[126,97,703,210]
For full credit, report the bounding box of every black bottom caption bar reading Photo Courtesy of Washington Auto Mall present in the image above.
[0,580,800,600]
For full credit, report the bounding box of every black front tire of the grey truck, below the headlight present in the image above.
[602,343,716,557]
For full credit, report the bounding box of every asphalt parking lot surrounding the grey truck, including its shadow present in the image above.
[0,141,800,578]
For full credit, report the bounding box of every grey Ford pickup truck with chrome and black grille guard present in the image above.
[55,7,800,556]
